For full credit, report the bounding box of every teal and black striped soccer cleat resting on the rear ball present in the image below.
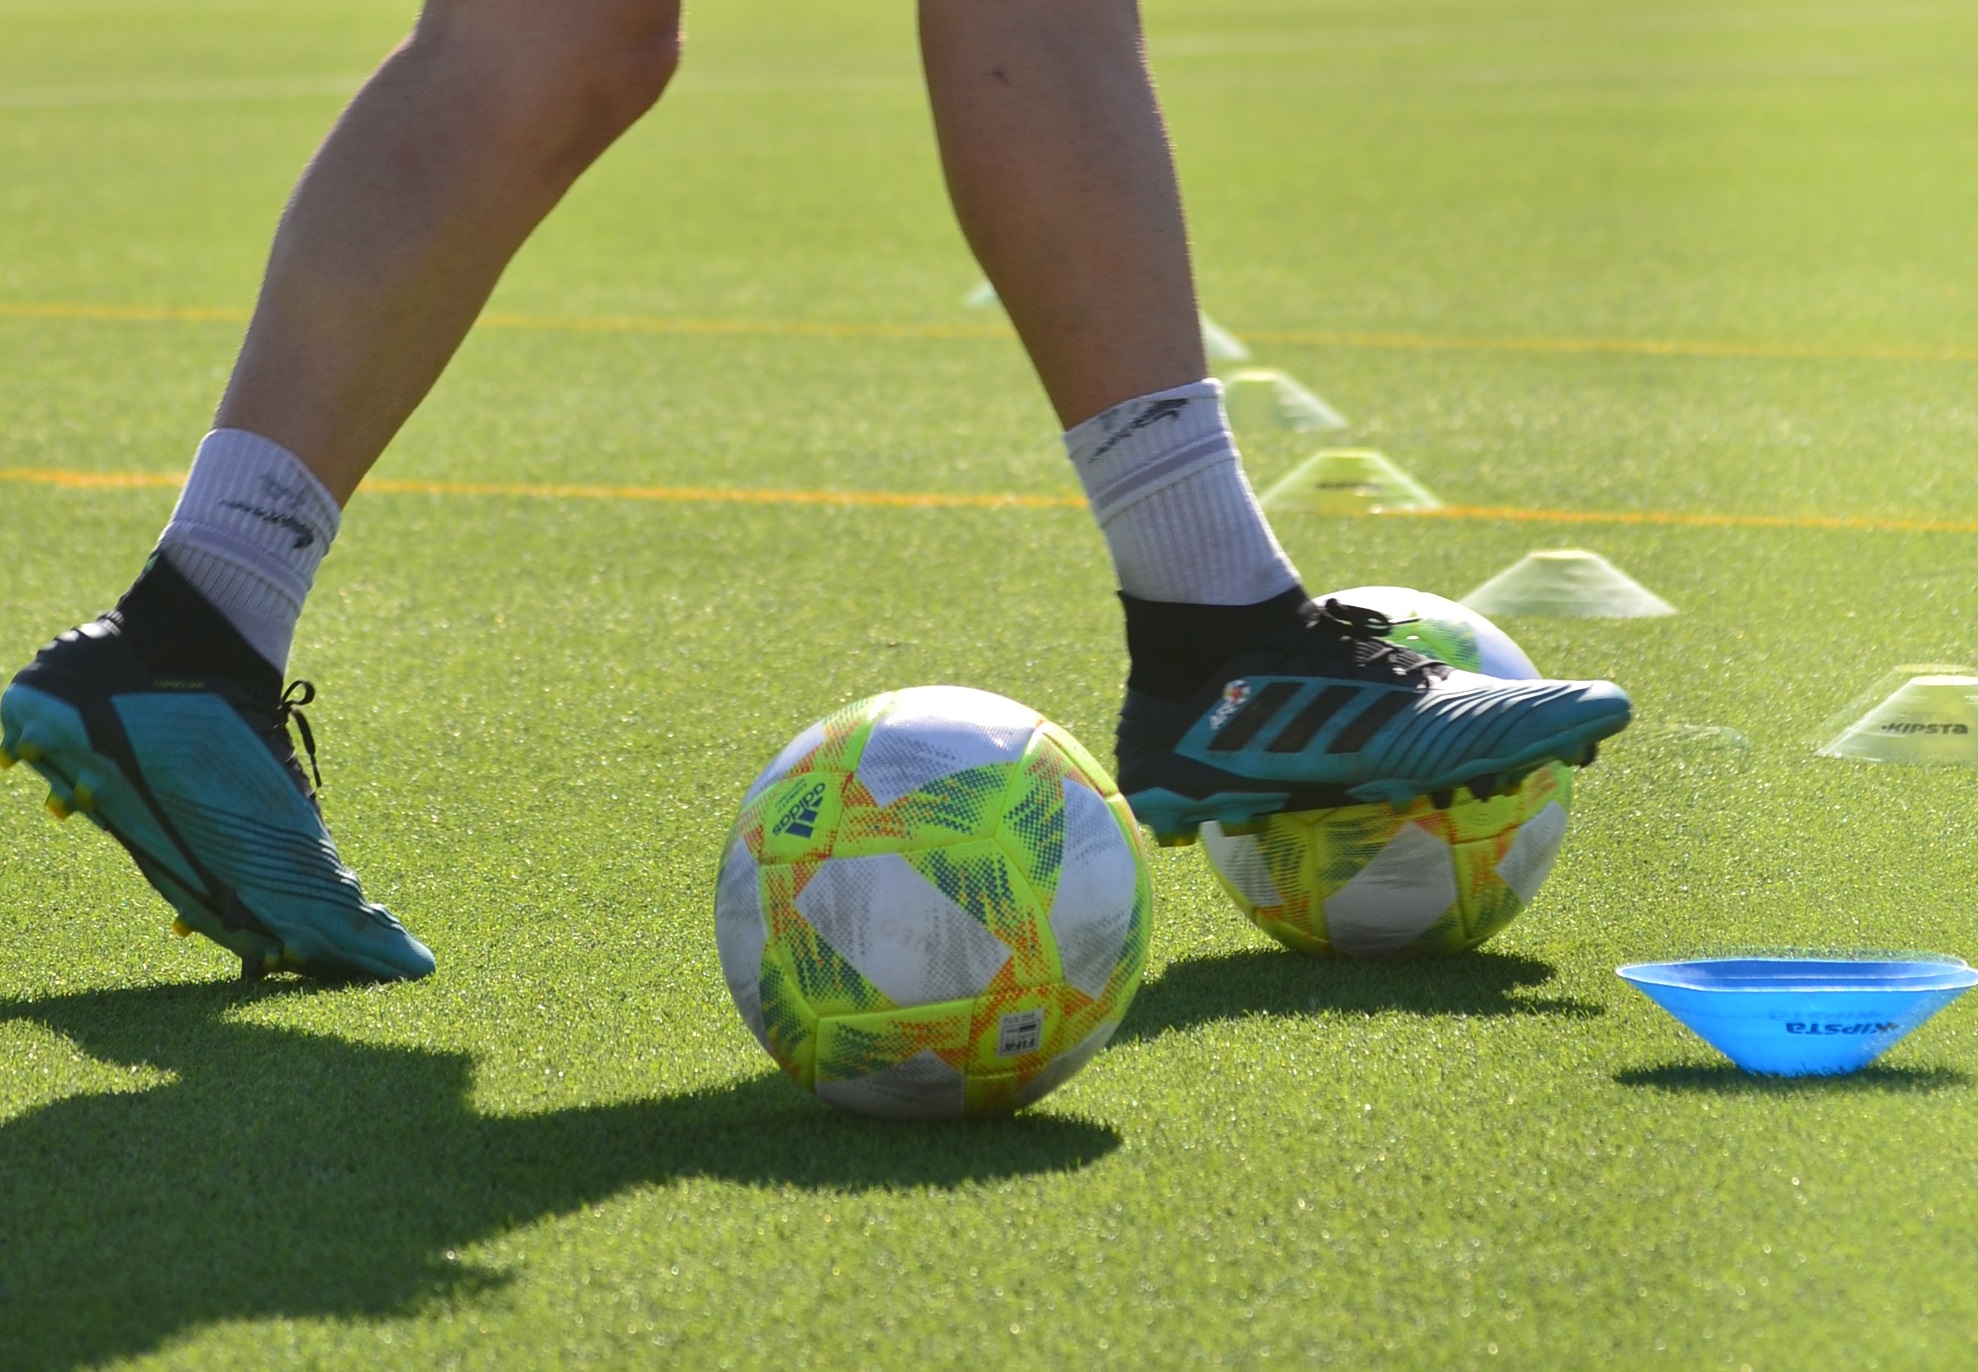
[1120,601,1630,844]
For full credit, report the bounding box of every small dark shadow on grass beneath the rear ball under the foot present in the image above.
[1118,949,1606,1042]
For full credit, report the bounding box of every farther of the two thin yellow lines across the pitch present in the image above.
[0,300,1978,362]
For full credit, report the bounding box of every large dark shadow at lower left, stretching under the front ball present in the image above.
[0,985,1120,1368]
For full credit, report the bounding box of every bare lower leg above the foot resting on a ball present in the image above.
[920,0,1209,427]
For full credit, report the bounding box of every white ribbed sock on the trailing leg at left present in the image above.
[158,429,342,670]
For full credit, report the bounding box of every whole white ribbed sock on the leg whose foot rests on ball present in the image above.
[1064,378,1298,605]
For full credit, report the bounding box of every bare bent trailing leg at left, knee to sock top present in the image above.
[216,0,678,502]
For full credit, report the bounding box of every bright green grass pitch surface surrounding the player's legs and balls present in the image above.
[0,0,1978,1370]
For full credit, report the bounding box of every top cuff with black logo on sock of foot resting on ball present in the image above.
[1064,378,1238,528]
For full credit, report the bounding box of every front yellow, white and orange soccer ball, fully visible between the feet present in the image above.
[714,686,1153,1119]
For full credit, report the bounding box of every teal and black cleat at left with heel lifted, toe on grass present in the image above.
[0,619,433,981]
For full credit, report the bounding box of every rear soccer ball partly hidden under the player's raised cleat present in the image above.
[1201,585,1573,957]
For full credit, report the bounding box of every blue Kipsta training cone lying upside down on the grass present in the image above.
[1614,955,1978,1077]
